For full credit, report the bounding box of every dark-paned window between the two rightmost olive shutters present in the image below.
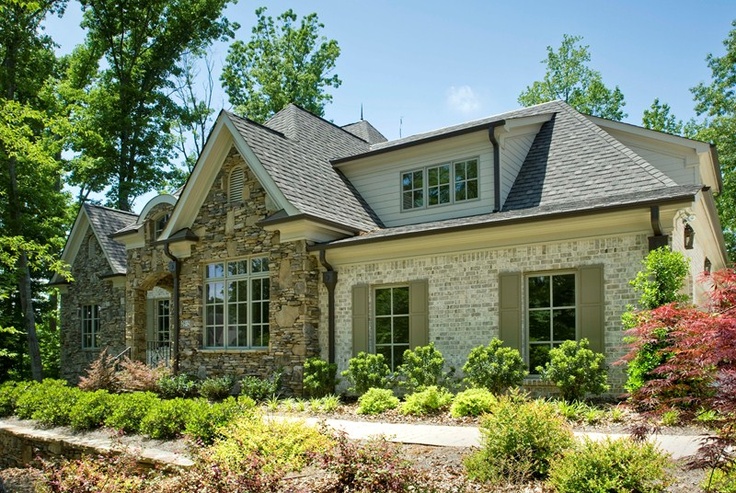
[527,273,577,374]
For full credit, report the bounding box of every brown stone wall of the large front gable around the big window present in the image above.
[174,148,319,393]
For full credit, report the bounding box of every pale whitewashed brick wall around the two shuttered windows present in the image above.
[320,234,648,391]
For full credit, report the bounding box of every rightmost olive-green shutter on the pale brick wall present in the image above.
[580,265,606,353]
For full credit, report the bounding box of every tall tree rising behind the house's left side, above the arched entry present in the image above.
[73,0,237,210]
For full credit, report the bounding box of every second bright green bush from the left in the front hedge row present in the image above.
[16,379,82,426]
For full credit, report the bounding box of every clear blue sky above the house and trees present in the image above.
[46,0,736,209]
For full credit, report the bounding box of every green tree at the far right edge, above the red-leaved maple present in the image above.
[691,21,736,261]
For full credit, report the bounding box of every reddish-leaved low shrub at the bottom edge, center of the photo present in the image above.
[321,433,429,492]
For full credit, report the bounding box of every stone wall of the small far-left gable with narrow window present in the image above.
[61,228,126,384]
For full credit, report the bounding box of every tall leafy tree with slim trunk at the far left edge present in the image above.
[0,0,66,380]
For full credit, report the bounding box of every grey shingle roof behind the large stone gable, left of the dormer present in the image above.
[227,105,381,231]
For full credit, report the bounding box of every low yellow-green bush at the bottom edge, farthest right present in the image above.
[549,438,671,493]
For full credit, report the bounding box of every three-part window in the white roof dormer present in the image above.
[401,158,478,211]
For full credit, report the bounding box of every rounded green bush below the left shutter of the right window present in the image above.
[463,337,529,394]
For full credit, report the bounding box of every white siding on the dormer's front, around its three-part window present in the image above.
[339,131,494,227]
